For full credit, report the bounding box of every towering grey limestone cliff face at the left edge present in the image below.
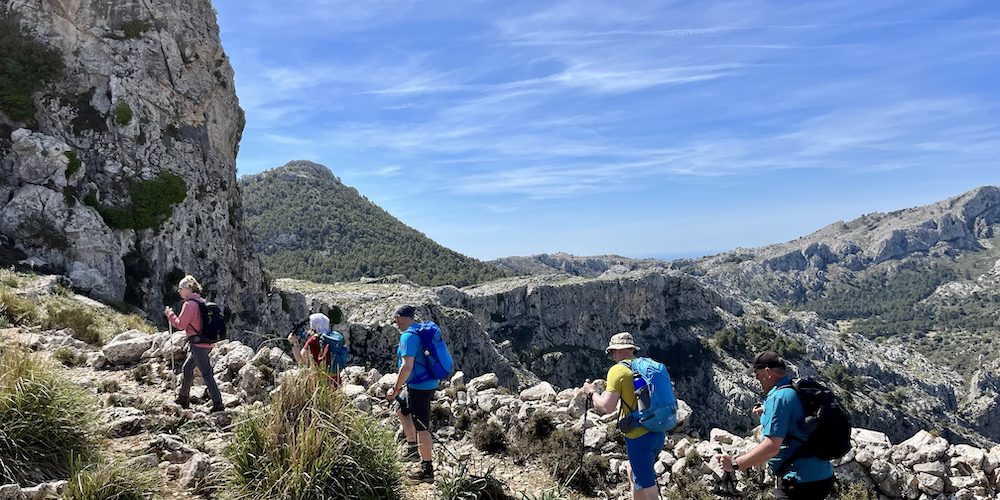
[0,0,273,334]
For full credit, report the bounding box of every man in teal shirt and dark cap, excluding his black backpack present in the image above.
[716,351,834,500]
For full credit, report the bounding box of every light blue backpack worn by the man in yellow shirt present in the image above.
[621,358,677,432]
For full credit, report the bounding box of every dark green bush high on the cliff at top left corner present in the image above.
[0,7,63,121]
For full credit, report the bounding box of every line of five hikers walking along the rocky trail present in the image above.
[164,275,846,500]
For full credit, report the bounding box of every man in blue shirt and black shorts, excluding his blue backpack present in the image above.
[385,305,440,483]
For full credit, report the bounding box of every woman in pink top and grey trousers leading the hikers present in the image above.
[163,274,226,413]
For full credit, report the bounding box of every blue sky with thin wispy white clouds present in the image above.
[215,0,1000,259]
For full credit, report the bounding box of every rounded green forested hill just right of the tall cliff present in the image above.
[240,161,507,286]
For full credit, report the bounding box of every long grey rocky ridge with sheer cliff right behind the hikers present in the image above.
[277,271,1000,445]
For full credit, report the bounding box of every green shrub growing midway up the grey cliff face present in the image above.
[83,172,187,229]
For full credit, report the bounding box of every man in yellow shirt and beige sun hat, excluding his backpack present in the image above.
[582,332,667,500]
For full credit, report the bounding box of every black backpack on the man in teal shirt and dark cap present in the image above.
[777,377,851,477]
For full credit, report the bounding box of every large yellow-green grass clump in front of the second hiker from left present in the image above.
[226,371,403,500]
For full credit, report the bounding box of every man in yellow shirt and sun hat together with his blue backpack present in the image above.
[582,332,676,500]
